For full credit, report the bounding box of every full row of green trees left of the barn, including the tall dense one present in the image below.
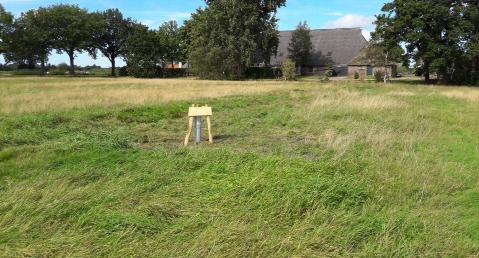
[0,0,286,79]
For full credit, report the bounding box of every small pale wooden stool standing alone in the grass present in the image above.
[185,104,213,146]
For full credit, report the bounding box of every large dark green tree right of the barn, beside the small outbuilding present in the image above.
[373,0,470,83]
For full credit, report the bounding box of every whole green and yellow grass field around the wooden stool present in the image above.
[0,77,479,257]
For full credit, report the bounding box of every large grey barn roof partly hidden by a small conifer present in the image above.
[271,28,368,65]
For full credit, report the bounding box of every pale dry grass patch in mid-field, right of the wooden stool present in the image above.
[288,85,408,160]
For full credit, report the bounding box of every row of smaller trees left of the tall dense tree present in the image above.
[0,4,186,76]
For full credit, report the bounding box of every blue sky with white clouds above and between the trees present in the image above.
[0,0,387,67]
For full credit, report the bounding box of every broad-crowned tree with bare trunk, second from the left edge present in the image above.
[48,4,101,75]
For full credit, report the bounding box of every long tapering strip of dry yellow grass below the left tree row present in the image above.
[0,77,296,114]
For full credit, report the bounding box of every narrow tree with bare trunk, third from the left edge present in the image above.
[95,9,131,77]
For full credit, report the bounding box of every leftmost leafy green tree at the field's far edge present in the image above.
[6,8,52,73]
